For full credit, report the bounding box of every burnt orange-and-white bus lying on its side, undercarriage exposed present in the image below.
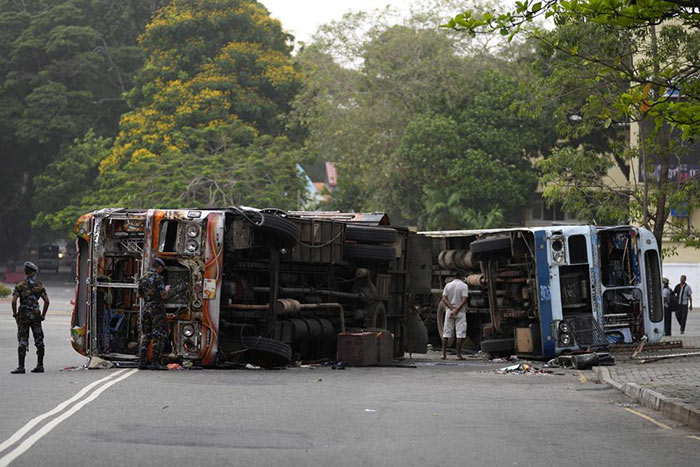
[71,207,430,366]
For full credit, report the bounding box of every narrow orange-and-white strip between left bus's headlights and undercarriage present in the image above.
[200,213,224,365]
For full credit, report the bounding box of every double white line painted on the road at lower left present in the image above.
[0,368,138,467]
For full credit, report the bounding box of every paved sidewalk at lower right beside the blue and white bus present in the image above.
[595,335,700,430]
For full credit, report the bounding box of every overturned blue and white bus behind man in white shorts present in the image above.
[419,225,664,358]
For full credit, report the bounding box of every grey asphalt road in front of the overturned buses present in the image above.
[0,312,700,466]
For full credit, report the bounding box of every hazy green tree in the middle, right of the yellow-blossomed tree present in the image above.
[294,5,554,228]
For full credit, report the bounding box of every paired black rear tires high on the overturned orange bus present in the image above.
[345,225,398,262]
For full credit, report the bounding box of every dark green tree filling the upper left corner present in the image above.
[0,0,161,258]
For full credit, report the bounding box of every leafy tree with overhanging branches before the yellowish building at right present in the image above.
[445,0,700,249]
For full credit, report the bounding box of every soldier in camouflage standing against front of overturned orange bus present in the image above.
[139,258,169,370]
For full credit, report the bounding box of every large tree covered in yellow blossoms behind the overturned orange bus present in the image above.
[92,0,303,208]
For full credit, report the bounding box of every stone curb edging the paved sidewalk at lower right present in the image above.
[595,366,700,430]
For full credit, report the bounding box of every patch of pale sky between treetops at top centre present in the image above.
[258,0,411,43]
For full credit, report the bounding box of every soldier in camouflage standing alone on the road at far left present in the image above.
[10,261,49,375]
